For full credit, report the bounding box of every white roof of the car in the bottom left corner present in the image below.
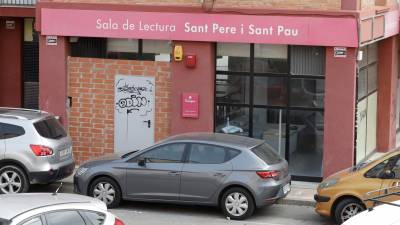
[0,193,101,220]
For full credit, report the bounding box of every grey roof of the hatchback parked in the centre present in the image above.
[165,132,264,149]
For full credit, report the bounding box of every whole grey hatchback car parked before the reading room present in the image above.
[74,133,291,220]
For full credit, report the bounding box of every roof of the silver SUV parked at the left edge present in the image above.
[0,107,51,120]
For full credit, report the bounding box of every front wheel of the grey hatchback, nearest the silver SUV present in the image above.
[89,177,121,208]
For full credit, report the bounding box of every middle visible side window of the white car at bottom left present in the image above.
[45,210,86,225]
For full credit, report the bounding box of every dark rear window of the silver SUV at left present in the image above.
[34,117,67,139]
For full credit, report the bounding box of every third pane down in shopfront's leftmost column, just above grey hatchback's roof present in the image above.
[215,105,250,136]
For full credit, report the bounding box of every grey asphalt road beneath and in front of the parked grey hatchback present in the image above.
[30,183,334,225]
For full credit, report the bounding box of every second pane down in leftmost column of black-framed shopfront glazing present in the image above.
[215,74,250,104]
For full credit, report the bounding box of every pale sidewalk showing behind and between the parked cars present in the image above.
[62,172,319,206]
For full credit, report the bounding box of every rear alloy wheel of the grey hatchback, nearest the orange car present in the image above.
[225,192,249,216]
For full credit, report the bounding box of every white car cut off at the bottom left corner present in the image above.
[0,193,124,225]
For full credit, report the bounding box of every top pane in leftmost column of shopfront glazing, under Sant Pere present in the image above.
[217,43,250,72]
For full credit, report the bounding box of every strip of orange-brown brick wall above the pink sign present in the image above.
[42,0,341,10]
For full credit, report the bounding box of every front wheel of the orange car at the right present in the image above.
[335,198,365,224]
